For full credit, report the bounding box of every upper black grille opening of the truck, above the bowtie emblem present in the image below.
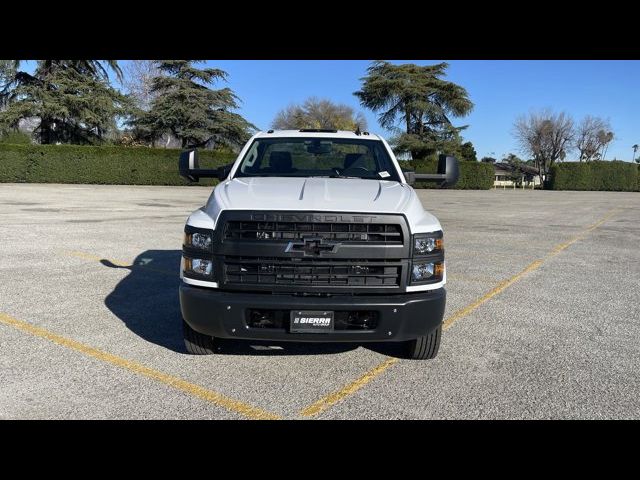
[224,220,403,245]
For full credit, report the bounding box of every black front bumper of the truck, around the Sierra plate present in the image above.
[180,283,446,342]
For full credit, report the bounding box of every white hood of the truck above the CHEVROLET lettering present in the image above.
[204,177,440,232]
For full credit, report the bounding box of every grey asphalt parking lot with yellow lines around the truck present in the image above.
[0,184,640,419]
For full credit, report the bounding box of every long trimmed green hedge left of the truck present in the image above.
[0,144,236,185]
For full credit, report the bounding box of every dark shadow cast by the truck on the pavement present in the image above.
[100,250,404,356]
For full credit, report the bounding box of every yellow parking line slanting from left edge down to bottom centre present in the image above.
[0,313,280,420]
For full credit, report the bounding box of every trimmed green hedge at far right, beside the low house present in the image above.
[549,161,638,192]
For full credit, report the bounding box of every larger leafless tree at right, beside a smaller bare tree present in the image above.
[514,110,575,178]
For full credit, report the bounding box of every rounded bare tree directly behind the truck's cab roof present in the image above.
[272,97,367,130]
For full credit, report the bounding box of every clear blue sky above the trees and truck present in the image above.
[20,60,640,160]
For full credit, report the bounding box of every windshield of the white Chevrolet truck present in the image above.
[235,138,400,182]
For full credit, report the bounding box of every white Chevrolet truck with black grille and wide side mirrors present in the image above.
[179,130,458,359]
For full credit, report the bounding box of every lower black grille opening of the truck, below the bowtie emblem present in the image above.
[224,257,402,287]
